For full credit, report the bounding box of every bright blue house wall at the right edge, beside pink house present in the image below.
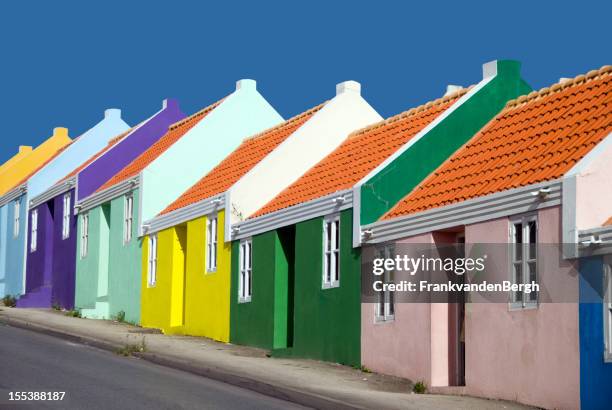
[579,256,612,409]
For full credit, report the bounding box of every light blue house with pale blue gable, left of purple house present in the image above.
[0,109,130,297]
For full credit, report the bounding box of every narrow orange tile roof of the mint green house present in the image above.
[96,99,223,192]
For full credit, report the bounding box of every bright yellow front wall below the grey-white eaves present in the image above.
[141,211,231,342]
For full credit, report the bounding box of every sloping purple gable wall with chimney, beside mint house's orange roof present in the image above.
[77,98,185,201]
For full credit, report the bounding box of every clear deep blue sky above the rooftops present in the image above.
[0,0,612,162]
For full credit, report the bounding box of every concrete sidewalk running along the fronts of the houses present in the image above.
[0,307,529,410]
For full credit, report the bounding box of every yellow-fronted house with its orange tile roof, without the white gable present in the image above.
[141,105,322,342]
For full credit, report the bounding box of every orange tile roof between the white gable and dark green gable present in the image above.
[252,89,468,218]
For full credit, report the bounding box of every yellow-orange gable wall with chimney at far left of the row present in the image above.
[0,127,70,195]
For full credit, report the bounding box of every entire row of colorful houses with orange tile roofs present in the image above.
[0,60,612,408]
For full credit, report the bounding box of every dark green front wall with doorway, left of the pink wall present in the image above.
[230,210,361,366]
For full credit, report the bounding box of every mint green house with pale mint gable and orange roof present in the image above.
[75,80,283,323]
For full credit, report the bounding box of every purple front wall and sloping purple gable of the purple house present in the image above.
[17,99,185,309]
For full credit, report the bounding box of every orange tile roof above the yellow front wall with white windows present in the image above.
[160,103,325,215]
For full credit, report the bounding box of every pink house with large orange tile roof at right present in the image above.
[361,66,612,409]
